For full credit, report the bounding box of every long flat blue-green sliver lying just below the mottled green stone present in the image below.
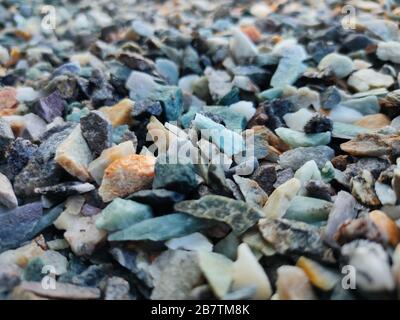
[108,213,212,241]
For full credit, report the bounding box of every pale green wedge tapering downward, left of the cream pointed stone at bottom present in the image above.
[199,251,233,298]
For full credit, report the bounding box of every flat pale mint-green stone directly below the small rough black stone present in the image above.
[275,128,331,148]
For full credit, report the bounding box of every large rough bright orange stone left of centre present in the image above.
[99,154,156,202]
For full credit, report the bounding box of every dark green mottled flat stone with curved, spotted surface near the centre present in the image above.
[175,195,262,234]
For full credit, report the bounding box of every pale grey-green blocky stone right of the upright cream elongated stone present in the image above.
[284,196,332,223]
